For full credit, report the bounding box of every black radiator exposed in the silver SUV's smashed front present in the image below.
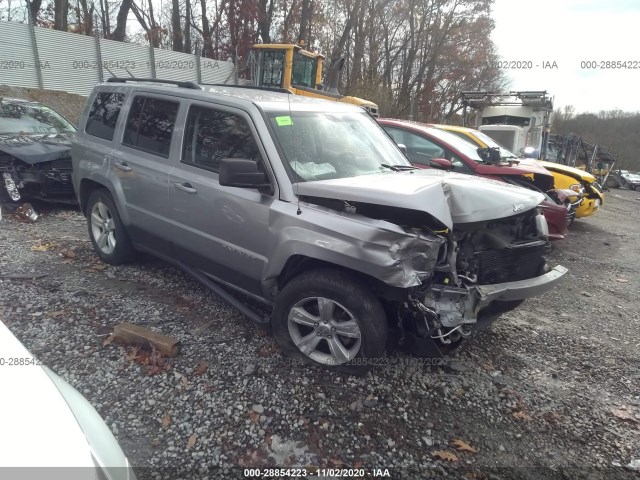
[477,245,545,285]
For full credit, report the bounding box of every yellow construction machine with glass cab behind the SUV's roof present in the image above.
[250,43,378,117]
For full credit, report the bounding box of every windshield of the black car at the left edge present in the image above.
[0,100,76,135]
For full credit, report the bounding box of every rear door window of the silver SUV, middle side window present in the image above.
[122,96,179,157]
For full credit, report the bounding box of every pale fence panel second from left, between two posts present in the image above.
[35,28,100,95]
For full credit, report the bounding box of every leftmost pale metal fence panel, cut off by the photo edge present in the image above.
[0,22,39,88]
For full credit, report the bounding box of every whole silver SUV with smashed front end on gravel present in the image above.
[72,79,566,373]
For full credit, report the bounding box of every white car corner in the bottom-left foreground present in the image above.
[0,321,136,480]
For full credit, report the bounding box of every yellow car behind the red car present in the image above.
[432,125,604,218]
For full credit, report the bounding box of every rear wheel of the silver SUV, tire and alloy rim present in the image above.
[87,189,135,265]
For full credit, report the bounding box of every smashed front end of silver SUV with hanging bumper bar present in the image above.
[398,209,567,355]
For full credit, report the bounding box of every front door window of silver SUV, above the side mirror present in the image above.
[182,106,260,172]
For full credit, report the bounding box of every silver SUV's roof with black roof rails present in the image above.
[96,79,363,112]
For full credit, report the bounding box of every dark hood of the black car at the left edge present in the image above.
[0,134,71,165]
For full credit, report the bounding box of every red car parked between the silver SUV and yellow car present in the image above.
[378,118,575,240]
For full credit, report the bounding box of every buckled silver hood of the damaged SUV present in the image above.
[293,170,544,228]
